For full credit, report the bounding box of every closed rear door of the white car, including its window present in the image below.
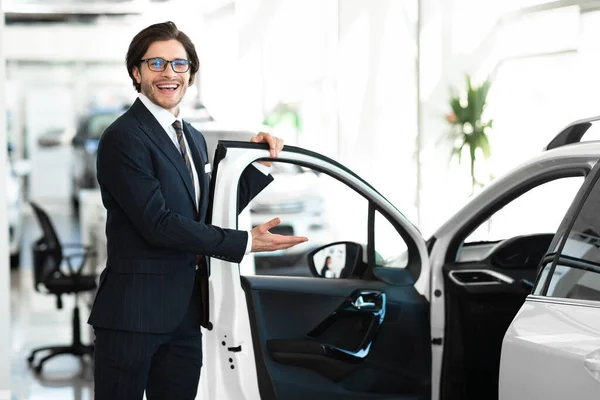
[499,118,600,400]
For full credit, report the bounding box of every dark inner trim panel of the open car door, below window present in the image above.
[243,276,431,400]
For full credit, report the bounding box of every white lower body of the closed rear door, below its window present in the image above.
[499,296,600,400]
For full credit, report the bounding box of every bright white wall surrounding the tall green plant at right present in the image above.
[420,0,600,234]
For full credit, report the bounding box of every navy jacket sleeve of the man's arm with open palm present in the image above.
[97,127,248,262]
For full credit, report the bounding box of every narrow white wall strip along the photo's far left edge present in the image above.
[0,0,12,400]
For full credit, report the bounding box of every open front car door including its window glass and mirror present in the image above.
[201,142,431,400]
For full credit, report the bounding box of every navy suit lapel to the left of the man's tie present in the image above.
[130,99,196,206]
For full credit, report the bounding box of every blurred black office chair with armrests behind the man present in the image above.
[27,202,96,374]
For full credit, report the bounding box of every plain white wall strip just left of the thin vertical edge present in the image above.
[336,0,417,223]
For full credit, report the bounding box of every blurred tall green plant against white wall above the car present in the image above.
[446,75,493,191]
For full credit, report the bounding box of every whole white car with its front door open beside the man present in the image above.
[193,116,600,400]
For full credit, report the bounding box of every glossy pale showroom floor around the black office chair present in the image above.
[11,203,94,400]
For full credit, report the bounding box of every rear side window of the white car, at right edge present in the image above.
[534,177,600,301]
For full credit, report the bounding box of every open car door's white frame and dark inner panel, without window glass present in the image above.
[206,142,431,400]
